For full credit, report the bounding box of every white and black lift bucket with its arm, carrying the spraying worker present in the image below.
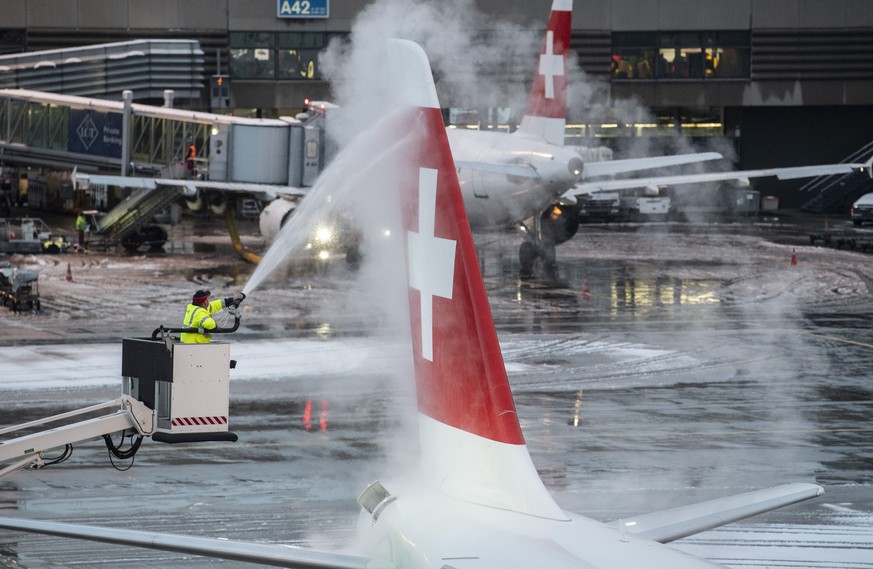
[0,307,240,478]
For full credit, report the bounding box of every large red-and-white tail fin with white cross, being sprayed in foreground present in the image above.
[389,40,566,519]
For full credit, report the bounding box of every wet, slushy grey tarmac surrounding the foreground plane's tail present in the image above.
[0,213,873,569]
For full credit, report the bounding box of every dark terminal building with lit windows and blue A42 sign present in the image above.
[0,0,873,207]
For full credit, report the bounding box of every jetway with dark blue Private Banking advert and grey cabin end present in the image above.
[0,89,325,183]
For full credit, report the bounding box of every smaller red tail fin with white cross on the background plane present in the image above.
[519,0,573,146]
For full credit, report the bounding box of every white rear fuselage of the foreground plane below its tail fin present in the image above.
[358,484,722,569]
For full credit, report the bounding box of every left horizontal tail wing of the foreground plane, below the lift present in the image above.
[0,518,395,569]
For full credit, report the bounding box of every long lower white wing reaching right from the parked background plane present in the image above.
[563,160,867,198]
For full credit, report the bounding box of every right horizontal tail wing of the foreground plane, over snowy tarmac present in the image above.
[612,484,824,543]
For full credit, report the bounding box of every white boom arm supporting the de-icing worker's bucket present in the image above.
[0,395,155,478]
